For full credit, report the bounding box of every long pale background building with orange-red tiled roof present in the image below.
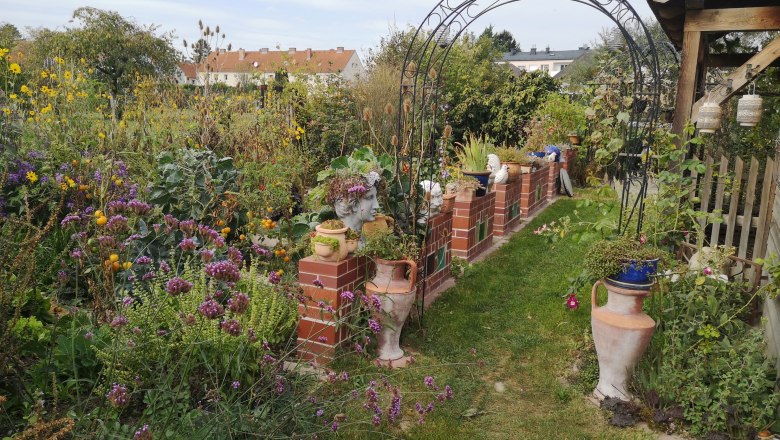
[180,47,365,87]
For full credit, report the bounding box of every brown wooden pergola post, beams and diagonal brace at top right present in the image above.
[648,0,780,135]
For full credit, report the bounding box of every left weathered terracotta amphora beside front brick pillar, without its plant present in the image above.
[366,258,417,362]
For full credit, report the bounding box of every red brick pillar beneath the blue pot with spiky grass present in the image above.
[452,192,496,261]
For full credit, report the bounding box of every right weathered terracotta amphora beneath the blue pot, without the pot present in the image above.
[590,281,655,400]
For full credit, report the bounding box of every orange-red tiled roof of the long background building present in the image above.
[202,49,355,73]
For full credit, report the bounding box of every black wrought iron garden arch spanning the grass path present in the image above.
[394,0,661,234]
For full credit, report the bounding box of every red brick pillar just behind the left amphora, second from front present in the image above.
[420,212,452,295]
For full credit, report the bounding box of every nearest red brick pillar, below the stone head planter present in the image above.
[298,256,366,365]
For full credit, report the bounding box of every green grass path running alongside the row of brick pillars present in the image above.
[332,199,654,440]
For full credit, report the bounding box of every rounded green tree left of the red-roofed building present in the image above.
[34,7,179,119]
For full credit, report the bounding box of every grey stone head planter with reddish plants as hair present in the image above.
[328,171,381,233]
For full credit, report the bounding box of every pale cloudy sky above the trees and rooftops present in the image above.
[0,0,652,56]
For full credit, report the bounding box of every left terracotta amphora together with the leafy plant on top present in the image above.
[357,229,420,366]
